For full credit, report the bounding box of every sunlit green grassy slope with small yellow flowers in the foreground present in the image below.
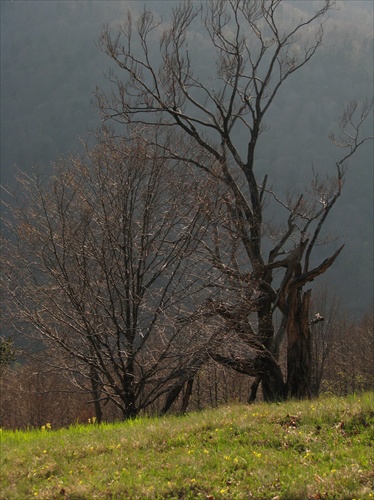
[0,393,374,500]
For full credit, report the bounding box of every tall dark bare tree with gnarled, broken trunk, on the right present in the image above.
[97,0,371,400]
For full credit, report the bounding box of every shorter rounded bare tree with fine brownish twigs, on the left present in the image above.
[2,132,216,420]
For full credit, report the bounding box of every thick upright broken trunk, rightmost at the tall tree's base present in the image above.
[286,289,312,399]
